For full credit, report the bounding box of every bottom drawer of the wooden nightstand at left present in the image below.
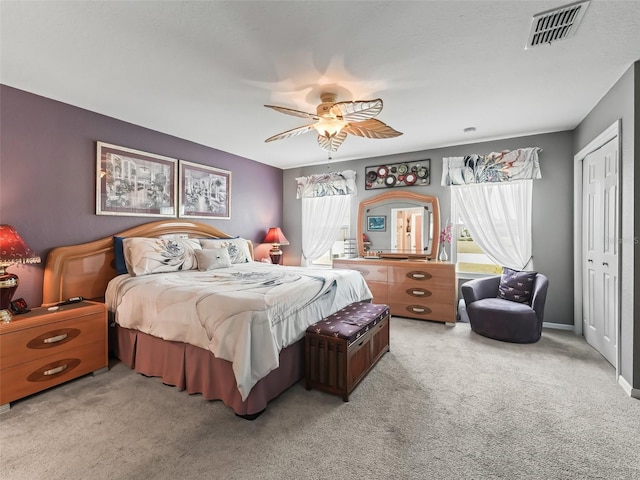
[0,339,107,404]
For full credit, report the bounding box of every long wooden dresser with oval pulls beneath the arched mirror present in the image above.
[333,258,456,324]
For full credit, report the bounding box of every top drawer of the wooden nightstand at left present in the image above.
[0,312,107,370]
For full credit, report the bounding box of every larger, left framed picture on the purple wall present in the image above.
[96,142,178,217]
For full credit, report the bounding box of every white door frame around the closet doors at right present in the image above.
[573,119,622,380]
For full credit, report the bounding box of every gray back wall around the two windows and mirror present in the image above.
[283,132,574,325]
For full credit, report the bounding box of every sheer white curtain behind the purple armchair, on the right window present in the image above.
[451,180,533,270]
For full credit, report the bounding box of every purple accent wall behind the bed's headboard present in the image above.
[0,85,283,306]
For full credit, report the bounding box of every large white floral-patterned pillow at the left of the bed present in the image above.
[122,237,201,276]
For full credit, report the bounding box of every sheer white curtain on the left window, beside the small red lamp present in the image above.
[301,195,351,267]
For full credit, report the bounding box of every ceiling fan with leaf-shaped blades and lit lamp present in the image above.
[265,92,402,152]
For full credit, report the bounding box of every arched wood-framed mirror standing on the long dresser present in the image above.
[358,191,440,259]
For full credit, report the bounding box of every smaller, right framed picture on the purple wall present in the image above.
[178,160,231,219]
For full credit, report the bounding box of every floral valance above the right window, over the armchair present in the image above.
[441,147,542,186]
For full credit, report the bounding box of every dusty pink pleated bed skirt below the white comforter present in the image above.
[111,325,304,416]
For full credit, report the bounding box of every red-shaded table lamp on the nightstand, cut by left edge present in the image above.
[0,225,40,310]
